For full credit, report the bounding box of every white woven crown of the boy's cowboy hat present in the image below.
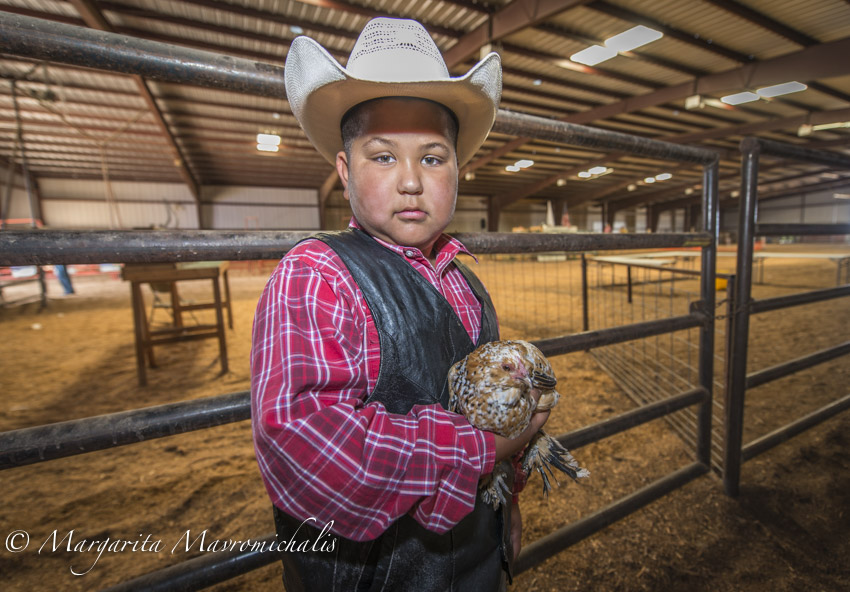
[346,18,450,82]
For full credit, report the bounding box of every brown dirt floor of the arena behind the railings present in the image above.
[0,245,850,592]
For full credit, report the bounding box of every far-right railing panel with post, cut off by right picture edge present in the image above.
[723,137,850,496]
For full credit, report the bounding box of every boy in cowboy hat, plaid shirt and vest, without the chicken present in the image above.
[252,19,547,592]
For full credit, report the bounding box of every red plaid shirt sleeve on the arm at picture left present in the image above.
[251,241,495,540]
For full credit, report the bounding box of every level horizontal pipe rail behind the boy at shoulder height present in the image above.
[0,230,713,266]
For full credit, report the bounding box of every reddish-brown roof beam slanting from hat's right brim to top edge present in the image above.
[443,0,589,68]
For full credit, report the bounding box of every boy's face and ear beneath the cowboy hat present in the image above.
[336,98,457,257]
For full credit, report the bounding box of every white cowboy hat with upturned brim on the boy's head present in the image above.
[284,18,502,166]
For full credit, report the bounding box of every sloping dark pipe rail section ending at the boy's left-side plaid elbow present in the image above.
[0,391,251,470]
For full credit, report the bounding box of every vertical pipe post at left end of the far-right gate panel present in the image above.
[723,139,760,497]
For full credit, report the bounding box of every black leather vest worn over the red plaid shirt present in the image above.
[275,229,512,592]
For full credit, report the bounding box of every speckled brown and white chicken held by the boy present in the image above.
[449,340,590,508]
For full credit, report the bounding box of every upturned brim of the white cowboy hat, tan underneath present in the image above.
[284,37,502,166]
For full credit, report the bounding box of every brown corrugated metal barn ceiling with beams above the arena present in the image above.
[0,0,850,222]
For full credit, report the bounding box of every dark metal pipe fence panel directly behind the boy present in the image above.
[0,13,718,590]
